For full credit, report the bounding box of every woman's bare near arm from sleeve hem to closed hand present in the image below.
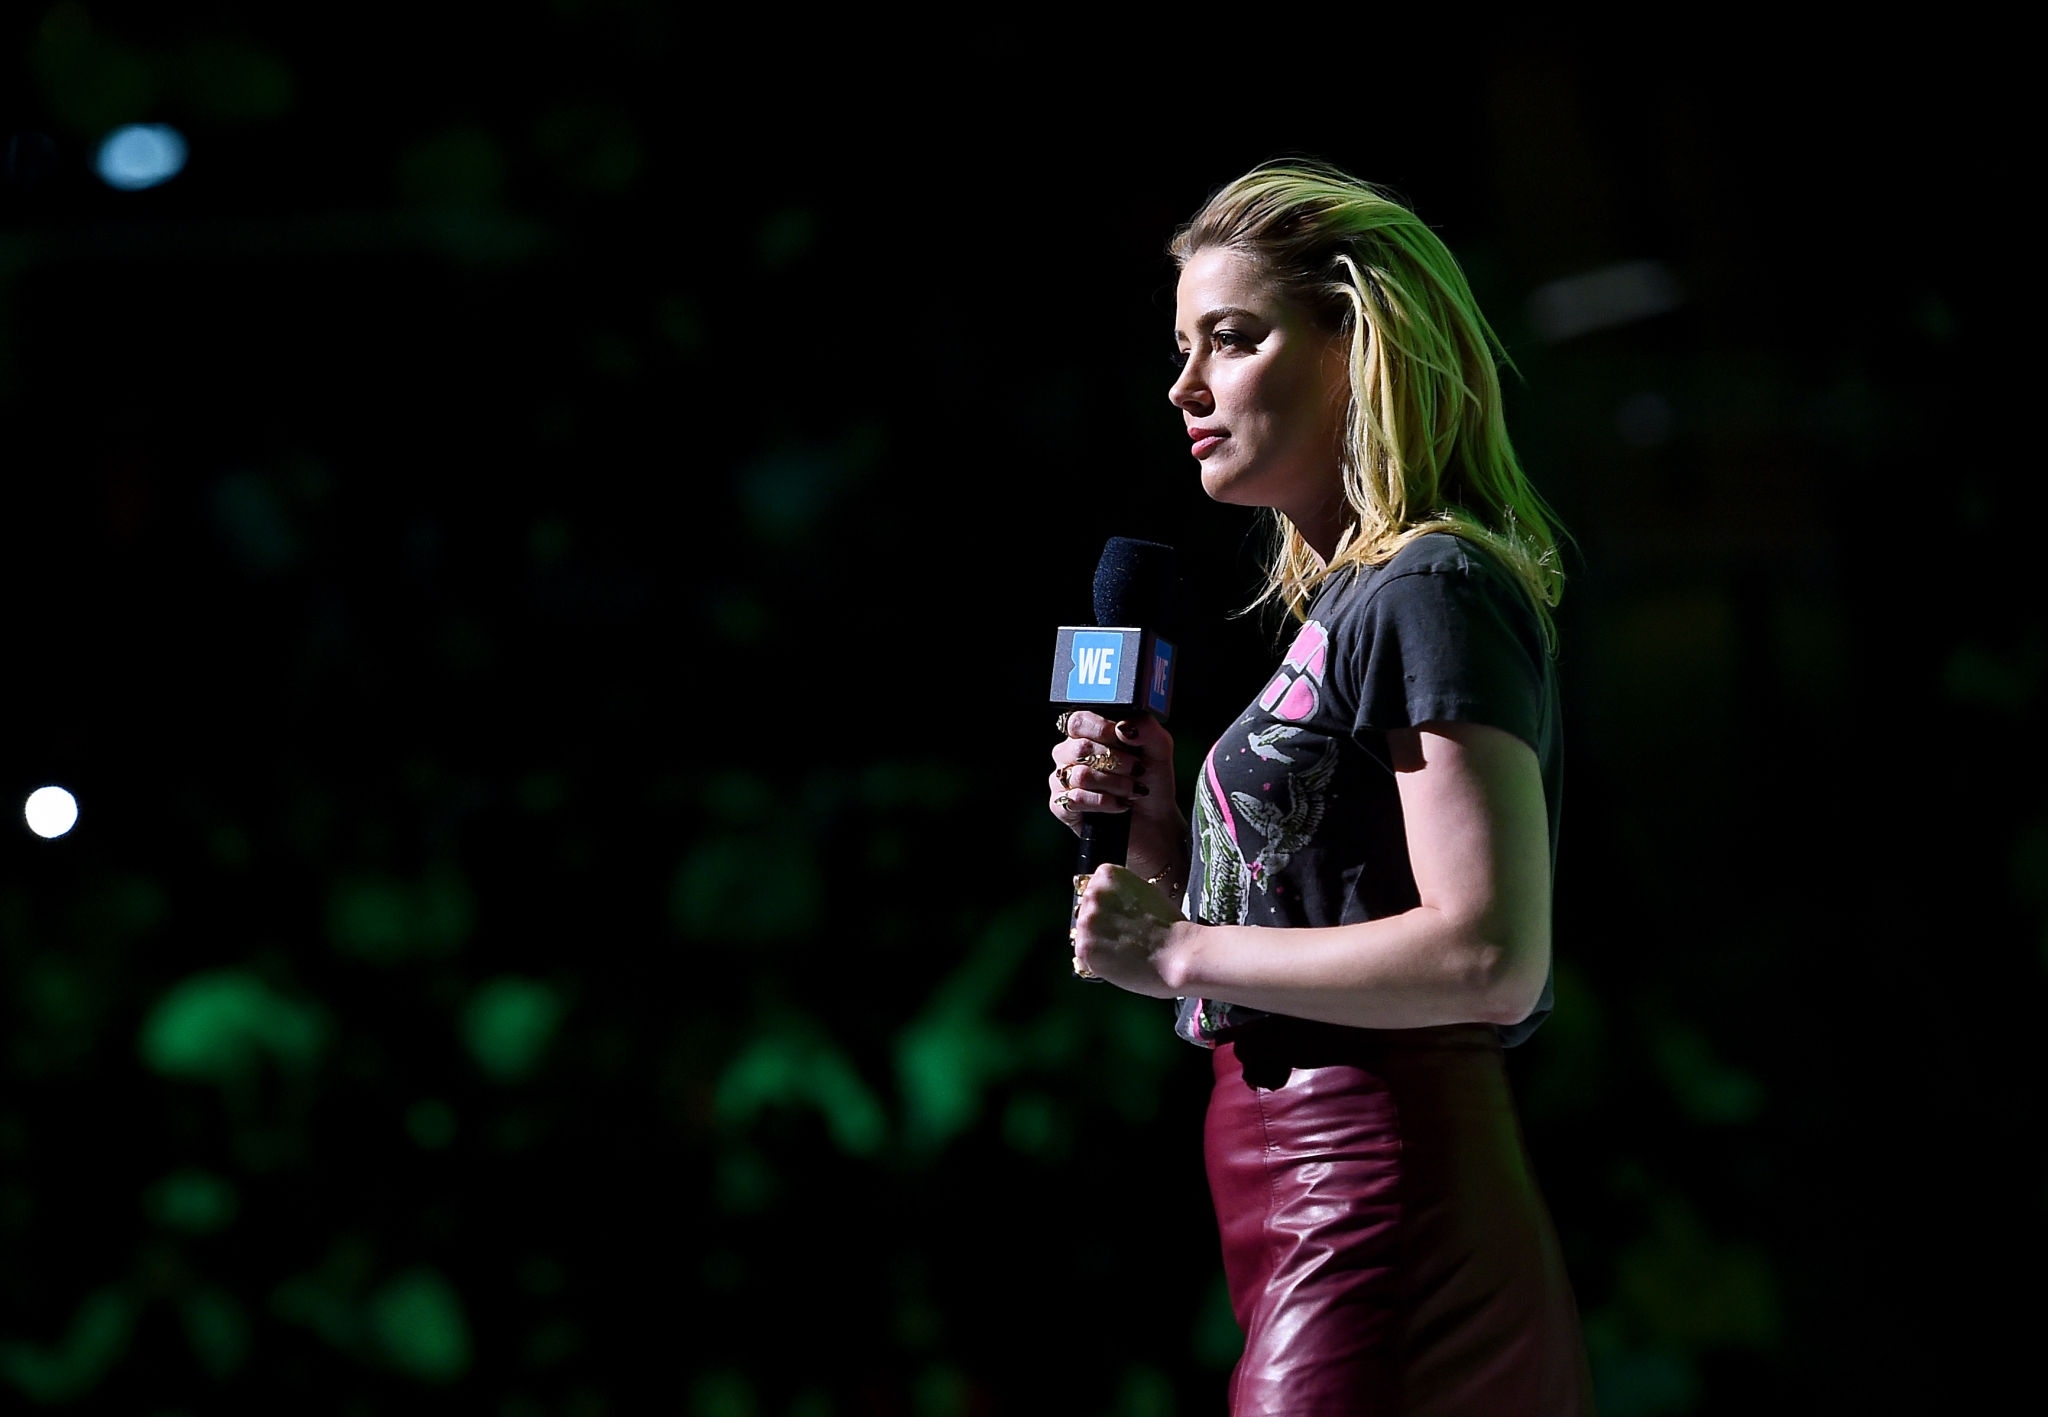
[1077,723,1550,1028]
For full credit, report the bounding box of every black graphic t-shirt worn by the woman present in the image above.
[1176,532,1563,1046]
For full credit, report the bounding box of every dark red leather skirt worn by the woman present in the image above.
[1204,1018,1591,1417]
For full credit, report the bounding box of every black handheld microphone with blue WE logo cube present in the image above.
[1053,536,1182,876]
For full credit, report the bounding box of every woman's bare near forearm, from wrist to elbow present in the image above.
[1155,905,1550,1028]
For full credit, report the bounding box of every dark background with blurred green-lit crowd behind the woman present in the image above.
[0,13,2048,1417]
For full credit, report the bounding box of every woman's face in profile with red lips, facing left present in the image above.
[1167,246,1352,559]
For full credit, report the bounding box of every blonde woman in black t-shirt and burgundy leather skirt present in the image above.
[1049,164,1589,1417]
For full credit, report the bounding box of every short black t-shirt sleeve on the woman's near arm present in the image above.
[1339,536,1548,754]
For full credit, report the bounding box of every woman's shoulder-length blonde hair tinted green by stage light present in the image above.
[1167,162,1565,643]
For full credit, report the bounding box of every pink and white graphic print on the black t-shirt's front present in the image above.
[1196,620,1337,926]
